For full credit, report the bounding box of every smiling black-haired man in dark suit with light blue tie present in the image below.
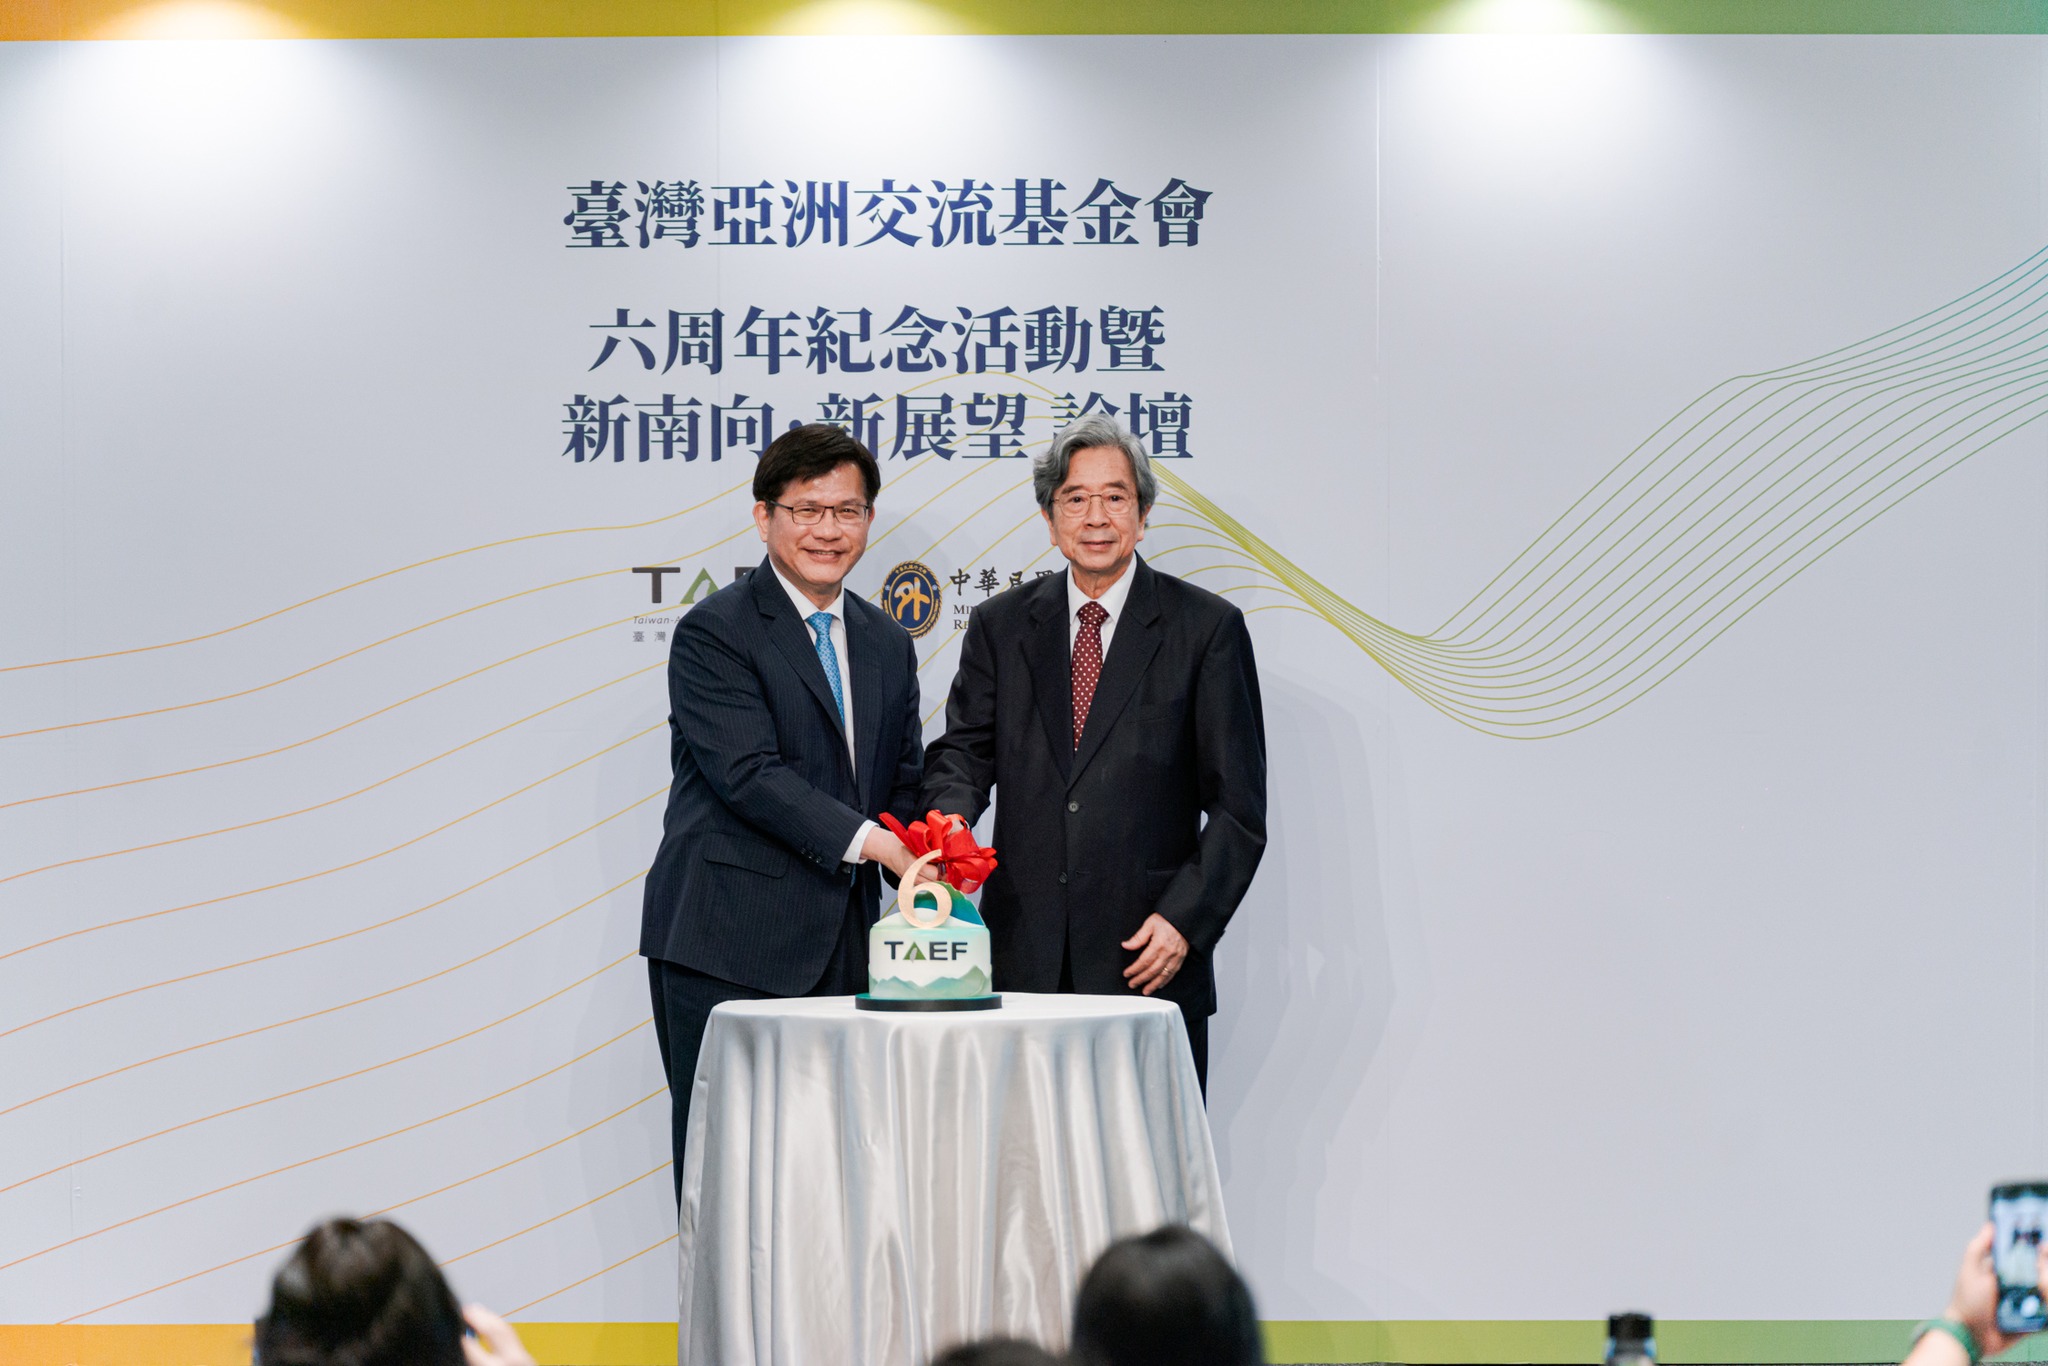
[641,424,924,1196]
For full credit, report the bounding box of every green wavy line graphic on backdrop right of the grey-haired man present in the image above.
[1155,248,2048,739]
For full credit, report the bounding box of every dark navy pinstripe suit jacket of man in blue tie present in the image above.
[641,559,924,995]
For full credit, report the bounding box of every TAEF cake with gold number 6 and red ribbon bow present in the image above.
[854,811,1001,1010]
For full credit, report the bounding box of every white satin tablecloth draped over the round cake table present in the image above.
[678,993,1231,1366]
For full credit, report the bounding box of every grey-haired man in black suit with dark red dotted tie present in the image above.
[918,418,1266,1090]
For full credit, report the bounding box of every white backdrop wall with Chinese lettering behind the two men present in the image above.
[0,37,2048,1323]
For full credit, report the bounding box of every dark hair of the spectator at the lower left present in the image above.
[256,1219,463,1366]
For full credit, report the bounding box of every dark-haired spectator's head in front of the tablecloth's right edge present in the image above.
[1069,1227,1266,1366]
